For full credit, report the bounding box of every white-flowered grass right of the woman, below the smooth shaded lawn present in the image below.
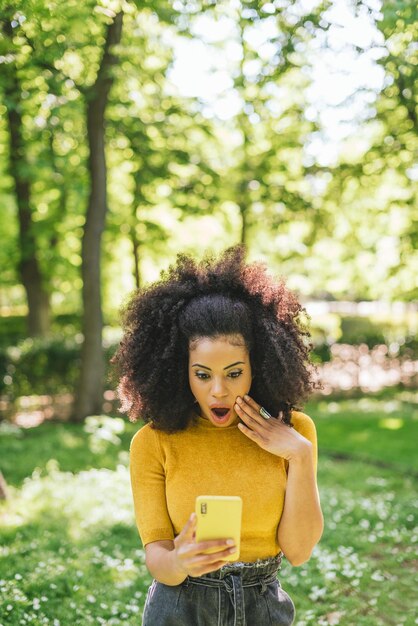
[283,458,418,626]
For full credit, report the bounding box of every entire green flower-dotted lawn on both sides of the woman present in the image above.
[0,393,418,626]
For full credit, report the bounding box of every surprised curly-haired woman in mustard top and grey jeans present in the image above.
[115,246,323,626]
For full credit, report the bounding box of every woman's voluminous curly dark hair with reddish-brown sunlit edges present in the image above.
[112,246,318,432]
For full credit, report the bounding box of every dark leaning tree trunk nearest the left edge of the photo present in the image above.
[3,20,50,336]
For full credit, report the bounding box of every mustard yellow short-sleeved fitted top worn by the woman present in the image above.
[130,411,317,562]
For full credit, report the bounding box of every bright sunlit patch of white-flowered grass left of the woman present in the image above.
[0,459,150,626]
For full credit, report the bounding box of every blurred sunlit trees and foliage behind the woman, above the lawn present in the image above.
[0,0,418,420]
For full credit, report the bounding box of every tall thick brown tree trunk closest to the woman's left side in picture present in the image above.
[73,12,123,421]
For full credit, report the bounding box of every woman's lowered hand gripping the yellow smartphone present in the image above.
[173,513,236,576]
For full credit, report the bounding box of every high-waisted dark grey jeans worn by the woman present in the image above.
[142,554,295,626]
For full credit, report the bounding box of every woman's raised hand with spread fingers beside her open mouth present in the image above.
[234,396,312,461]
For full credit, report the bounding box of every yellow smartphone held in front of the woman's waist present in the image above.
[195,496,242,561]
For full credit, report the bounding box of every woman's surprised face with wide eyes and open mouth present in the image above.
[189,335,251,427]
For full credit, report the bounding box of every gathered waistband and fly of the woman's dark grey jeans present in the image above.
[183,553,282,626]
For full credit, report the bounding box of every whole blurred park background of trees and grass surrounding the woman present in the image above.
[0,0,418,626]
